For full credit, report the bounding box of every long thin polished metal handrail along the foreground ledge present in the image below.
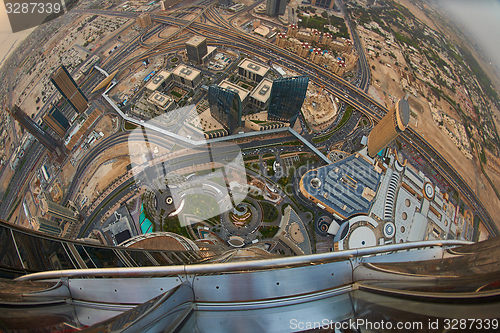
[16,240,473,281]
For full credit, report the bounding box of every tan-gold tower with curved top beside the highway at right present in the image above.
[368,99,410,157]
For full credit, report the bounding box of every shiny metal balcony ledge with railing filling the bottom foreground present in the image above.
[0,217,500,332]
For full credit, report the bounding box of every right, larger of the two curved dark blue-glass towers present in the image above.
[267,76,309,126]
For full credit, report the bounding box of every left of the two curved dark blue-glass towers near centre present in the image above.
[208,85,242,133]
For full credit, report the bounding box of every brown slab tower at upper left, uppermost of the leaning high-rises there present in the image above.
[50,66,88,114]
